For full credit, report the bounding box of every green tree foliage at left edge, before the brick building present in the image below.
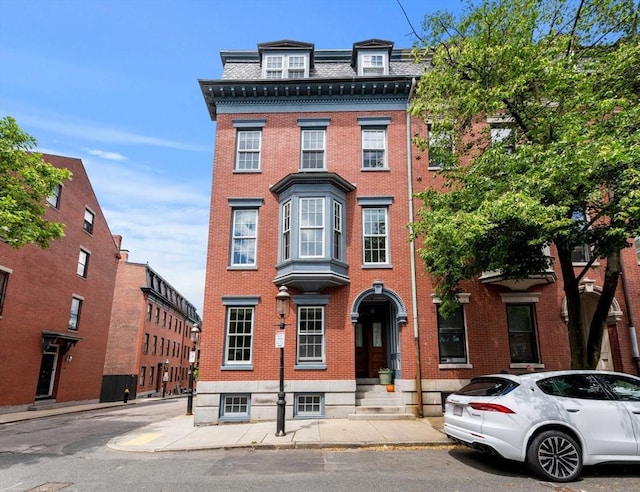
[0,116,71,249]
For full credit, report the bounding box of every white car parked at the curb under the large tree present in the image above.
[444,370,640,482]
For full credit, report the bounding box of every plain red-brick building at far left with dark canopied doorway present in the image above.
[0,154,118,413]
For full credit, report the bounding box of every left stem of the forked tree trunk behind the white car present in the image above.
[557,245,587,369]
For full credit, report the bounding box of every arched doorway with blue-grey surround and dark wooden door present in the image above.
[351,281,407,379]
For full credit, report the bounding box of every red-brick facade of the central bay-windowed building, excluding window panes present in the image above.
[195,40,640,424]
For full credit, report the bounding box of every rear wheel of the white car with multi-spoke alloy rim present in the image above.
[527,430,582,482]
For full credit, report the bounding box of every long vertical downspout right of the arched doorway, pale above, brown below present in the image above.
[406,77,424,417]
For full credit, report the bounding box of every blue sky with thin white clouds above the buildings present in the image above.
[0,0,460,315]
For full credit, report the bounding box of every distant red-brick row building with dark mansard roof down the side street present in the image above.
[101,241,201,401]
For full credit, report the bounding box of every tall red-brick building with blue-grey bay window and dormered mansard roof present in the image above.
[195,39,640,425]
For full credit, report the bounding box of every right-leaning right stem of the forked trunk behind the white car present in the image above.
[587,251,620,369]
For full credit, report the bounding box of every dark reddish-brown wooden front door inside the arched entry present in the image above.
[355,303,389,378]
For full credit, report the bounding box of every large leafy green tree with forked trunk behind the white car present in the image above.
[411,0,640,368]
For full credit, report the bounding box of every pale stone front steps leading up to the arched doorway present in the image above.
[348,383,416,420]
